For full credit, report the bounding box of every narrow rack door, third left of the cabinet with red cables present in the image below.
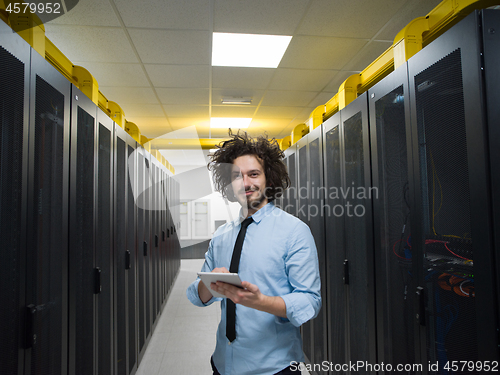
[323,112,348,372]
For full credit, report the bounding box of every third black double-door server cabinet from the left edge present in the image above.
[113,123,137,375]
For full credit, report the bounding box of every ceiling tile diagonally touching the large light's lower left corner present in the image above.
[145,65,210,88]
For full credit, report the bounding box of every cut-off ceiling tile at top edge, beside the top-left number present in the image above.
[45,0,120,26]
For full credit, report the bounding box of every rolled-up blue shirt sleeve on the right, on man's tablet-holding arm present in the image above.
[281,223,321,327]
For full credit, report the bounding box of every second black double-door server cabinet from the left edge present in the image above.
[69,86,114,374]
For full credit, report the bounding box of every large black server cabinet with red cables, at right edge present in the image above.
[408,11,500,374]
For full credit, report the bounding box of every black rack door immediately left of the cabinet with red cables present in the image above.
[368,65,418,373]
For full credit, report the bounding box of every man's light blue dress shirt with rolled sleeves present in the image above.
[186,203,321,375]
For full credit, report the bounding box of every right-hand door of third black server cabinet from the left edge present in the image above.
[127,142,141,374]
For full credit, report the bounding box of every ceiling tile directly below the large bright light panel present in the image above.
[212,66,276,89]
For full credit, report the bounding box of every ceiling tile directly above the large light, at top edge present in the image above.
[214,0,307,35]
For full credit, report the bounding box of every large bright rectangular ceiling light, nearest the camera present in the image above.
[212,33,292,68]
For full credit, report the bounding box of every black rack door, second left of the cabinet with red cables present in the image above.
[341,93,376,373]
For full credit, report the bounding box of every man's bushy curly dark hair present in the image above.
[207,129,290,202]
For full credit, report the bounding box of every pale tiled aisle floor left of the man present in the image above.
[137,259,308,375]
